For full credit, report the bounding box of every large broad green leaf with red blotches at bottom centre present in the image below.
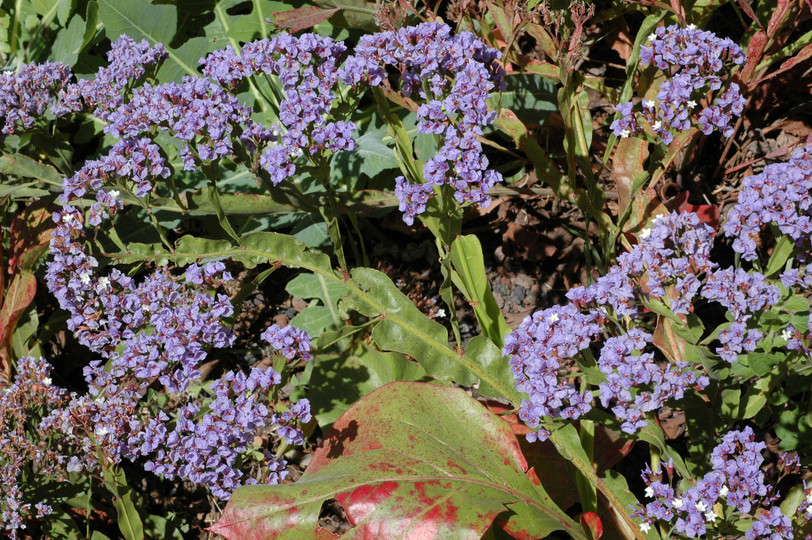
[211,382,587,540]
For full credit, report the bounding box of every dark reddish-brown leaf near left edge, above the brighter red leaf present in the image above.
[8,201,56,274]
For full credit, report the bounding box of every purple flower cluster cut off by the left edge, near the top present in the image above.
[0,62,72,135]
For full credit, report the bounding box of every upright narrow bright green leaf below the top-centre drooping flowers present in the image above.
[451,235,510,349]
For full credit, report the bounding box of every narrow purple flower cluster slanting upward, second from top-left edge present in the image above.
[51,35,168,121]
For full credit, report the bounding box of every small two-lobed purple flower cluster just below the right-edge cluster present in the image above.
[702,268,780,362]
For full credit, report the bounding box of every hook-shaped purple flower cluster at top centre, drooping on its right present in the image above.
[341,23,504,225]
